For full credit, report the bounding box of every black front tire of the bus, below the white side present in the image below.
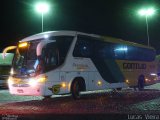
[71,78,86,100]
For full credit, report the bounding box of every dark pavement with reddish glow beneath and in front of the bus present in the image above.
[0,83,160,120]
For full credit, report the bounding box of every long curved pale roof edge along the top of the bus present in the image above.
[20,30,154,49]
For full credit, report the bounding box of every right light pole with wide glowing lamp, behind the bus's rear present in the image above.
[138,8,155,46]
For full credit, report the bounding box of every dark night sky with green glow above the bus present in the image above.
[0,0,160,53]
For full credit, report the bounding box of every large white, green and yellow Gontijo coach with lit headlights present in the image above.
[5,31,157,99]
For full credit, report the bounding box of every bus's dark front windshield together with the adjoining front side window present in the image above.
[13,36,73,76]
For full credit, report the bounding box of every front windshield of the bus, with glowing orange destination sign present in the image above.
[13,41,40,75]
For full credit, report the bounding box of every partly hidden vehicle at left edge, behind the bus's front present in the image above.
[0,53,14,87]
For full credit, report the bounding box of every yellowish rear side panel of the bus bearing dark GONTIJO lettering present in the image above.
[116,60,157,87]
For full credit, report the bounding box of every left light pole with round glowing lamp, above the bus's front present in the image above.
[35,2,49,32]
